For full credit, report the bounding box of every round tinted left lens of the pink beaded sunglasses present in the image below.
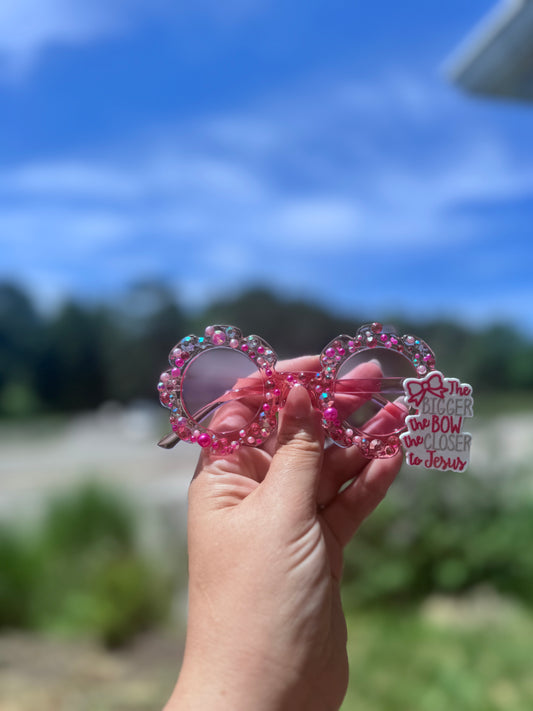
[181,348,264,434]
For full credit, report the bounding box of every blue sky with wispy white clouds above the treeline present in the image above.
[0,0,533,334]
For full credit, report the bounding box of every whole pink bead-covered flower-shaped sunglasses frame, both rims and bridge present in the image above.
[157,323,435,458]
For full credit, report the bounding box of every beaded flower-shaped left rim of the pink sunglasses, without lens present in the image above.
[157,326,280,455]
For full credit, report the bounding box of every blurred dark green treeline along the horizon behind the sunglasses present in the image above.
[0,283,533,417]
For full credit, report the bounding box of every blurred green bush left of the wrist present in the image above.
[0,483,176,648]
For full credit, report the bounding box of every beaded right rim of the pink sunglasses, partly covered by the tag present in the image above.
[319,322,435,458]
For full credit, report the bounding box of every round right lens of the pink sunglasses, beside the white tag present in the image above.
[335,348,417,436]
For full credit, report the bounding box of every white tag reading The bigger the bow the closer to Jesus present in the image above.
[400,370,474,472]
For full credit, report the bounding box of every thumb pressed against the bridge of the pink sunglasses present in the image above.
[264,385,324,512]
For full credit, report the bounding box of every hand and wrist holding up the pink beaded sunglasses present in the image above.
[167,357,401,711]
